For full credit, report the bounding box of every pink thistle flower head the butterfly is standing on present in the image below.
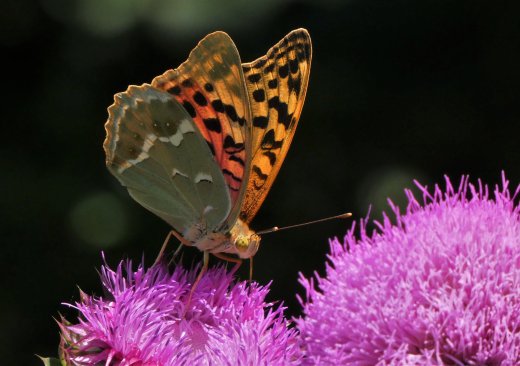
[60,261,301,366]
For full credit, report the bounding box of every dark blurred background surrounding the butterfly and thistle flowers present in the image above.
[0,0,520,365]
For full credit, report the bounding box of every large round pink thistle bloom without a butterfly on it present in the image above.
[297,176,520,365]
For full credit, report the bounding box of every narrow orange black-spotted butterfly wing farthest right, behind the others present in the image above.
[240,29,312,223]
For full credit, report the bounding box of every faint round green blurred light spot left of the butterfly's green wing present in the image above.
[70,192,128,249]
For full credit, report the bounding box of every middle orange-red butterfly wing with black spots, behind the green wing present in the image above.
[152,32,251,230]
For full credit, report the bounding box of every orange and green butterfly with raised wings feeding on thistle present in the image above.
[103,29,312,259]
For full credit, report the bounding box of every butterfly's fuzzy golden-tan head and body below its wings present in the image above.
[183,219,260,259]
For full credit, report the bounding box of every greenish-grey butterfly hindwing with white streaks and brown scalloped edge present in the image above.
[103,84,231,233]
